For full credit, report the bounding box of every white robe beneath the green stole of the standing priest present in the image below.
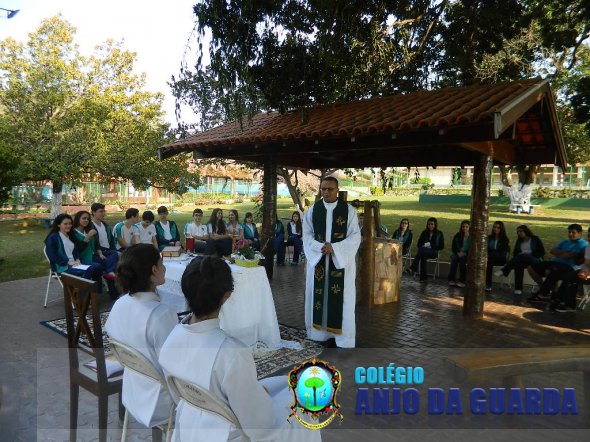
[303,201,361,348]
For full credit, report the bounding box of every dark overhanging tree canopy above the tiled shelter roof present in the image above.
[173,0,590,166]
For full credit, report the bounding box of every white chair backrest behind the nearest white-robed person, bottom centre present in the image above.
[167,376,245,437]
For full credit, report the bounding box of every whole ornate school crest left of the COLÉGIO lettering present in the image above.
[287,356,344,430]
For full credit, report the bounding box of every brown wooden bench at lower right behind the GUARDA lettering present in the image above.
[443,345,590,409]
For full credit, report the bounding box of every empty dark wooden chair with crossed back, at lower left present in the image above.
[61,273,124,442]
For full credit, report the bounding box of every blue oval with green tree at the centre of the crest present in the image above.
[296,365,334,412]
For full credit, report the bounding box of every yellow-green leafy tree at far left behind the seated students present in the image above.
[0,16,198,216]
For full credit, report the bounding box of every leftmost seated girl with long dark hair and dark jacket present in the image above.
[45,213,103,286]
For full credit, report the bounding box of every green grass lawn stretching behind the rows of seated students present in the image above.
[0,197,590,282]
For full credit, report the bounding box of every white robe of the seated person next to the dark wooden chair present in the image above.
[105,292,178,428]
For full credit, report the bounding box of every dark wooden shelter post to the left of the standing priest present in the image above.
[260,155,277,280]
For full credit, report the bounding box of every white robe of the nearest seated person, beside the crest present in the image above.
[160,318,321,442]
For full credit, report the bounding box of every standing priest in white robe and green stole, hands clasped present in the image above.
[303,177,361,348]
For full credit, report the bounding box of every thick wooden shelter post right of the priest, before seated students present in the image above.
[463,155,493,318]
